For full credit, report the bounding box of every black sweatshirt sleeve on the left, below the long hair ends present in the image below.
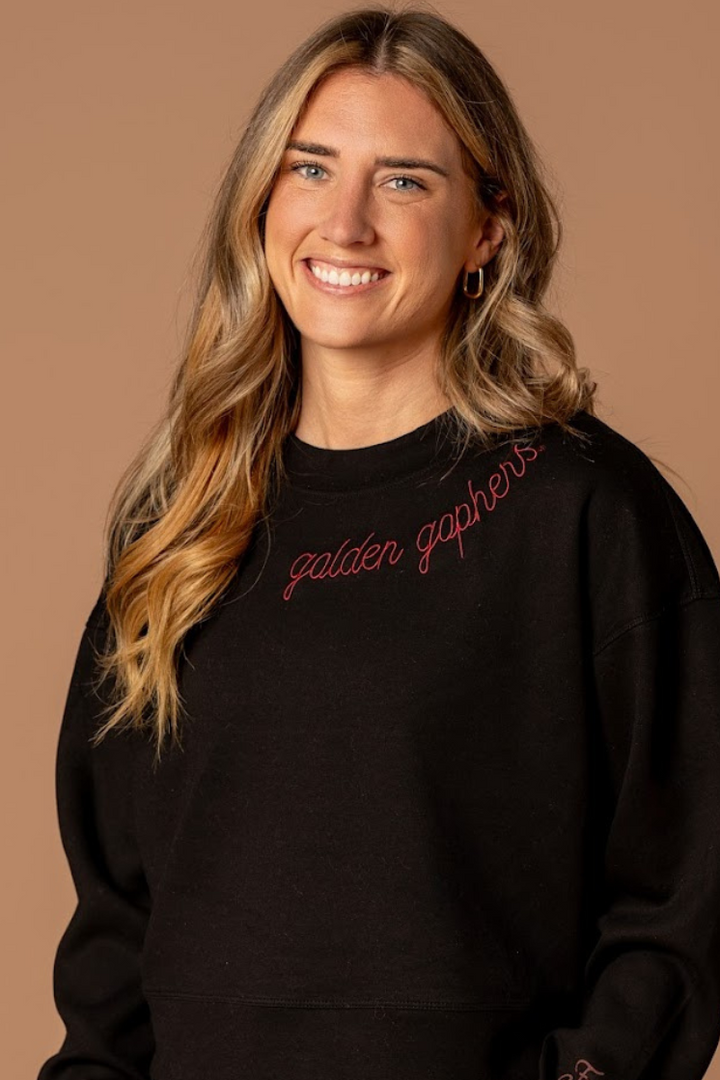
[38,594,154,1080]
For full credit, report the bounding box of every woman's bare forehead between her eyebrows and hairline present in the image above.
[293,69,460,157]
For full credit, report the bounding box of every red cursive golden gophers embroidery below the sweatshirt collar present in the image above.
[283,444,545,600]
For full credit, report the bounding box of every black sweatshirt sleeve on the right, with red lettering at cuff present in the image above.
[540,451,720,1080]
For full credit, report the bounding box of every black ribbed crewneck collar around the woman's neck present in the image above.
[284,408,462,492]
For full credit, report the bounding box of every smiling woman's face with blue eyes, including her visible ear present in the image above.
[266,69,502,367]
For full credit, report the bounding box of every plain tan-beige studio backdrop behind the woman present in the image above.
[0,0,720,1080]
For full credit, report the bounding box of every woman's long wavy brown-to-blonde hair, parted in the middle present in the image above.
[94,5,597,764]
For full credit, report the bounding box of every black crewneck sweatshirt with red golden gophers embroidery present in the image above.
[39,411,720,1080]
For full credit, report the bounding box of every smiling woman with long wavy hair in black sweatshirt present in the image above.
[40,8,720,1080]
